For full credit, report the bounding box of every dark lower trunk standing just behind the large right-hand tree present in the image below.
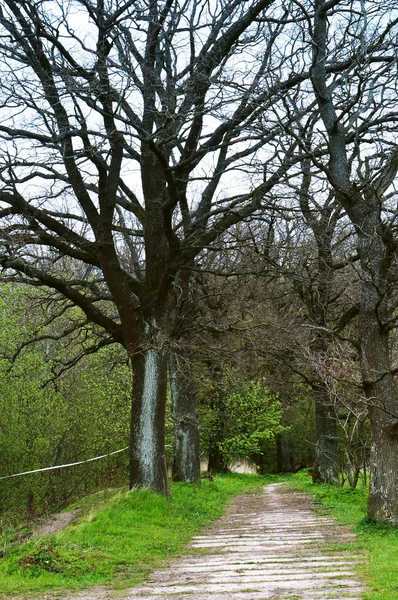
[315,399,339,483]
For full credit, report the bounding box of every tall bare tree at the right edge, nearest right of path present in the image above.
[284,0,398,525]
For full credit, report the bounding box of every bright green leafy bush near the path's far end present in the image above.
[219,381,285,462]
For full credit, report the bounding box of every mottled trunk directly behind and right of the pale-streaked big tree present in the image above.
[169,354,200,483]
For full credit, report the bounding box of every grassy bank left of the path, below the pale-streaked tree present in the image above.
[0,474,275,597]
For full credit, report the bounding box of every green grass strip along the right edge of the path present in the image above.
[289,473,398,600]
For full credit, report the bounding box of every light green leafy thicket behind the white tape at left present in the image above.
[0,285,131,519]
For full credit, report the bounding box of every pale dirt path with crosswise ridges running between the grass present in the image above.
[57,484,365,600]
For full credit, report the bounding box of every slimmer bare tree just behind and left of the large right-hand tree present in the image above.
[293,158,358,483]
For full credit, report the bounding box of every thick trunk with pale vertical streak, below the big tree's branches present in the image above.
[130,349,168,495]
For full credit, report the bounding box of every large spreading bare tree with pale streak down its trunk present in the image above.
[0,0,302,493]
